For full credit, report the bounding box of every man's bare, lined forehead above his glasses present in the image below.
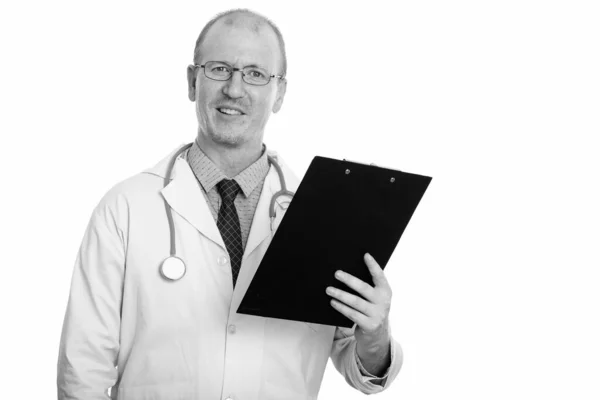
[200,20,280,70]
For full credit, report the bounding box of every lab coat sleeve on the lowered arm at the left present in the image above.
[57,195,125,400]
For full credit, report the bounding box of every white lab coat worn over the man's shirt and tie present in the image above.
[57,148,402,400]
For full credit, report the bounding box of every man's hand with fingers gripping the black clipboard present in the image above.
[327,253,392,348]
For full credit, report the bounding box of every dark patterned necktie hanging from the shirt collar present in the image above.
[217,179,244,288]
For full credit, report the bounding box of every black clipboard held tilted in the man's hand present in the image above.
[237,156,432,328]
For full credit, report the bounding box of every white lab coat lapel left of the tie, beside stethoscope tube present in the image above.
[161,158,225,249]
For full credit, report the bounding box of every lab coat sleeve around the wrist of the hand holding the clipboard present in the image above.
[331,324,403,394]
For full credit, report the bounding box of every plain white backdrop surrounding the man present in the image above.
[0,0,600,400]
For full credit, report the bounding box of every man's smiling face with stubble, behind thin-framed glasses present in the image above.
[188,22,285,147]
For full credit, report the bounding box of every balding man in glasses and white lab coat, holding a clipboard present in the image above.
[57,10,402,400]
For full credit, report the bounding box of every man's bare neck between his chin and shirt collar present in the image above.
[196,135,262,178]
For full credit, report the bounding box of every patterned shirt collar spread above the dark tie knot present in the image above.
[187,141,269,197]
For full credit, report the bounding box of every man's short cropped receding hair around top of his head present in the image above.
[194,8,287,77]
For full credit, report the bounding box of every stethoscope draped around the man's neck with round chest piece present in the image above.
[159,143,294,281]
